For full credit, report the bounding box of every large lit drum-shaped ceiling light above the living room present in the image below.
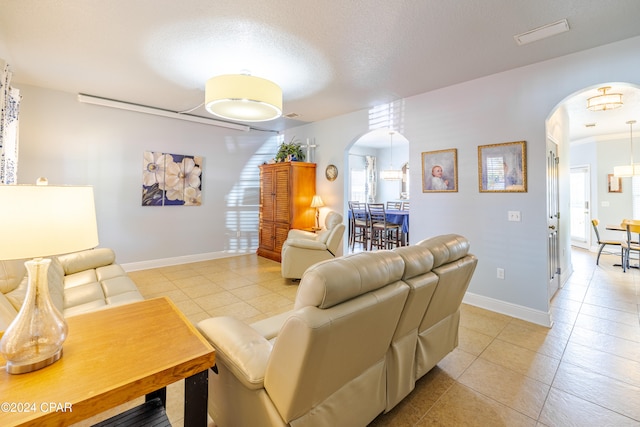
[204,74,282,122]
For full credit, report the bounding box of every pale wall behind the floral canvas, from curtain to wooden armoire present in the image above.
[18,86,277,263]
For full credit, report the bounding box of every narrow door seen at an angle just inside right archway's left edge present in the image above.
[547,139,560,301]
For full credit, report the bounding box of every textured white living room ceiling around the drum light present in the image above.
[0,0,640,139]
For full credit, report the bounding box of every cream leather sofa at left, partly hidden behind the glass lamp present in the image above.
[0,248,144,331]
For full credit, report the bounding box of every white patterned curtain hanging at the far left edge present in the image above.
[0,59,20,184]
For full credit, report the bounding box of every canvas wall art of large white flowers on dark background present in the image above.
[142,151,202,206]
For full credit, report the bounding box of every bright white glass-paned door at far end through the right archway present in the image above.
[569,165,591,249]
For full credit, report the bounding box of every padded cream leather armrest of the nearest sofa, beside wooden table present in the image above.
[197,317,272,390]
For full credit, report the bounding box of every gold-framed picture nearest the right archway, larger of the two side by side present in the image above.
[478,141,527,193]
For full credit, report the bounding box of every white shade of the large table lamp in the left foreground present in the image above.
[0,185,98,260]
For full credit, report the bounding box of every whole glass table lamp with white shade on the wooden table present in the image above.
[0,178,98,374]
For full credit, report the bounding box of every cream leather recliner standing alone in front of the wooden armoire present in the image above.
[281,211,345,279]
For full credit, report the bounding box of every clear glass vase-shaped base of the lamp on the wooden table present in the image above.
[0,258,67,374]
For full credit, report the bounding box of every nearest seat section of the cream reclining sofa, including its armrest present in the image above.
[198,251,409,427]
